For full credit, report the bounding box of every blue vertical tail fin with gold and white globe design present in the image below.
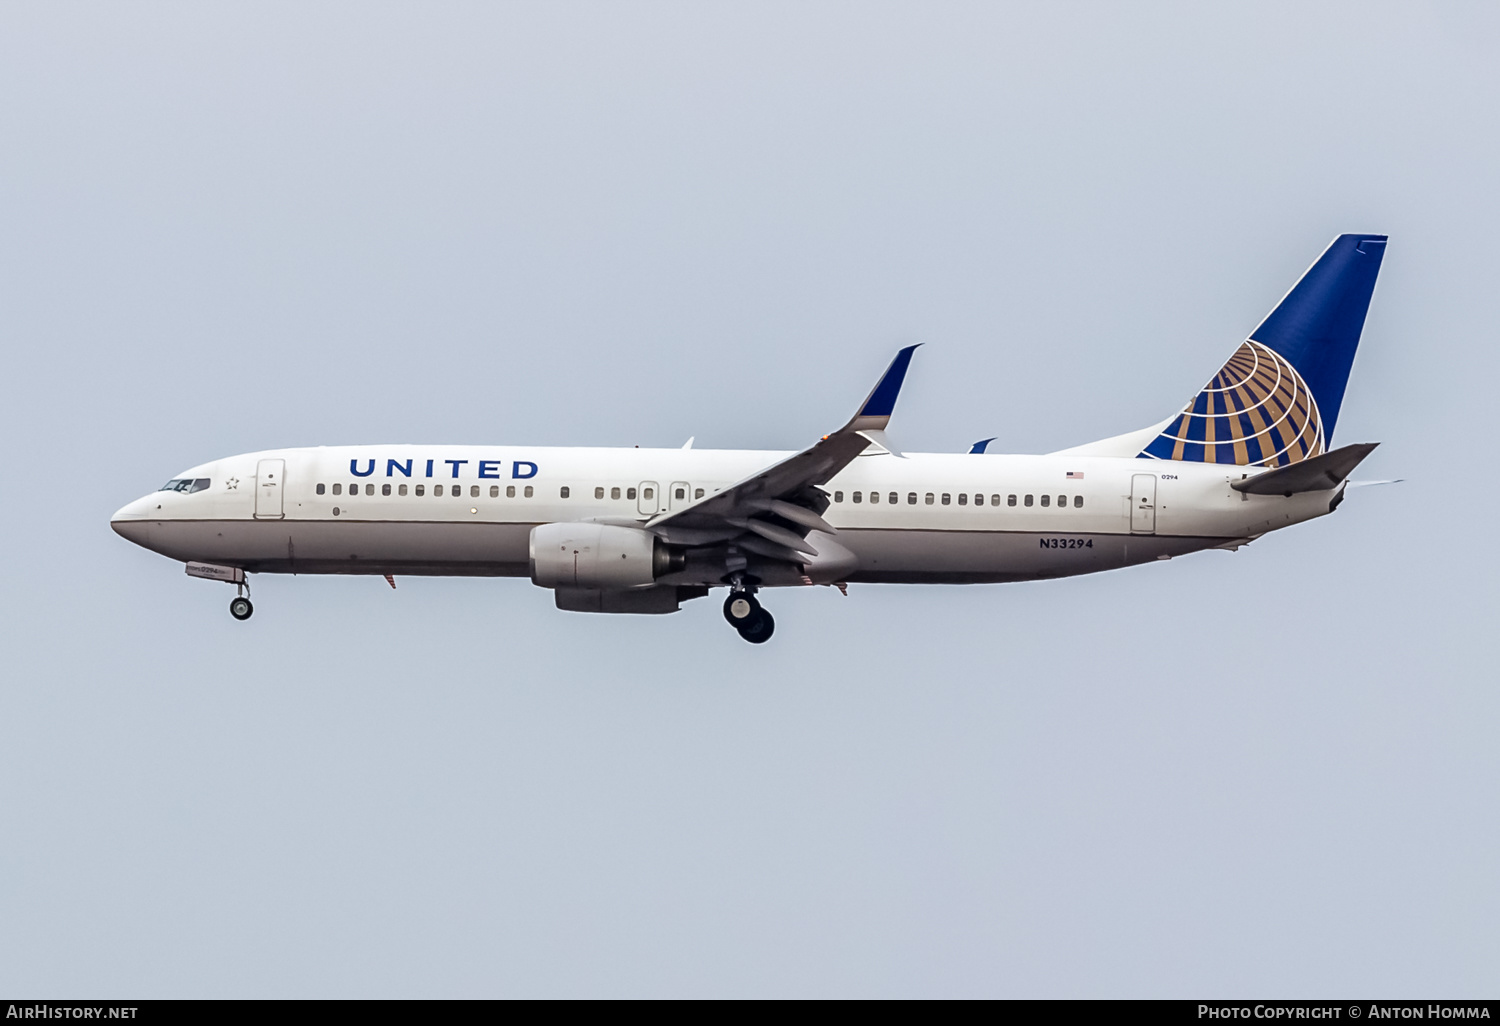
[1140,236,1386,467]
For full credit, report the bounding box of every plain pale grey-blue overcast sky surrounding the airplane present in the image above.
[0,2,1500,996]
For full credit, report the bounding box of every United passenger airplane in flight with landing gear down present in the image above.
[110,236,1386,644]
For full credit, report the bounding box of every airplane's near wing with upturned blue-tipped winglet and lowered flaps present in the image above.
[647,344,920,563]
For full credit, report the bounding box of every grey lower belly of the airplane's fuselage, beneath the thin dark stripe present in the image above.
[116,519,1226,585]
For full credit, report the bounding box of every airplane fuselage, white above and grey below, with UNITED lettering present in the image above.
[113,446,1337,585]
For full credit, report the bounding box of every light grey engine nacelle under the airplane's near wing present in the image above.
[531,524,683,591]
